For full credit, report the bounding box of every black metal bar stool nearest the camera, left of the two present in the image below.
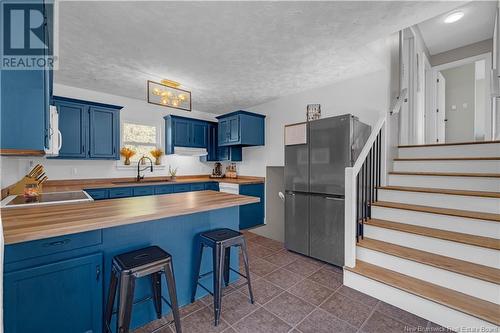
[104,246,182,333]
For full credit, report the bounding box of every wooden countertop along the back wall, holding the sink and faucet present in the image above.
[36,175,265,193]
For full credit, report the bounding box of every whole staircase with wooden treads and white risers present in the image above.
[344,141,500,330]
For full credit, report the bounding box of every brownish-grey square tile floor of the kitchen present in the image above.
[135,232,446,333]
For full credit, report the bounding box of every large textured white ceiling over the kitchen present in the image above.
[55,1,463,113]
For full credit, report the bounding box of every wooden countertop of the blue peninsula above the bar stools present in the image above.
[1,191,260,244]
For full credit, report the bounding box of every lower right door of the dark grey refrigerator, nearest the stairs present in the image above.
[309,195,344,266]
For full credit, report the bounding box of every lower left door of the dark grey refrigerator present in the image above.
[285,192,309,255]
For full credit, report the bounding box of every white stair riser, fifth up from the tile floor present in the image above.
[378,190,500,214]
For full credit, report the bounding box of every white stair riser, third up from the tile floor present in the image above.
[364,225,500,268]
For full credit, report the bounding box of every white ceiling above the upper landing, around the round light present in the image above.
[418,1,497,54]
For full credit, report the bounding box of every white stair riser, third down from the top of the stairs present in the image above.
[389,175,500,192]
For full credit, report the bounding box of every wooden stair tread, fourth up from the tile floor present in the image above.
[372,201,500,222]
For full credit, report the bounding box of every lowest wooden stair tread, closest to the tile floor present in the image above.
[345,260,500,325]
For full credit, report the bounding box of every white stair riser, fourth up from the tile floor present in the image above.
[372,206,500,239]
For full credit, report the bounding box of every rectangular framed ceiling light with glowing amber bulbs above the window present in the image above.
[148,80,191,111]
